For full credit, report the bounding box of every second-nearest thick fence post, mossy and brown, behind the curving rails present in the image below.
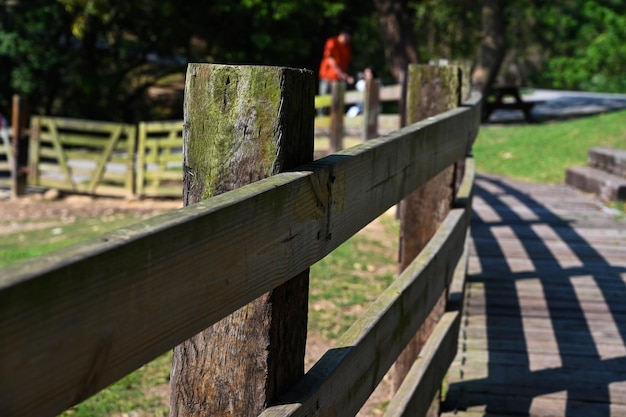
[394,65,461,412]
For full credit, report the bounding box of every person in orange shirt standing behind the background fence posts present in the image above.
[319,29,354,99]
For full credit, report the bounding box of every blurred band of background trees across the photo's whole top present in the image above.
[0,0,626,122]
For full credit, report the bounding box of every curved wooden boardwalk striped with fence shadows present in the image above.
[443,174,626,417]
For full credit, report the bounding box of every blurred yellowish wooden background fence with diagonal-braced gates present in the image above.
[20,85,400,197]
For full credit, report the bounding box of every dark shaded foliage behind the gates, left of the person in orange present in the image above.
[0,0,384,122]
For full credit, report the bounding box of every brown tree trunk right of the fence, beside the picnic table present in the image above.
[472,0,506,95]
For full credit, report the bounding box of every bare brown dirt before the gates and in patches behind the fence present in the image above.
[0,192,391,417]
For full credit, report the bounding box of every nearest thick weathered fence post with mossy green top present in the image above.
[170,64,315,417]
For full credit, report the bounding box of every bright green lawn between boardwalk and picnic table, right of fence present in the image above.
[474,111,626,184]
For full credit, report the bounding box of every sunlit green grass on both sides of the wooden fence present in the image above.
[0,111,626,417]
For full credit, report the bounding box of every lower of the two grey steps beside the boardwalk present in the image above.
[565,167,626,201]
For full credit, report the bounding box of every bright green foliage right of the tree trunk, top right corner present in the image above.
[503,0,626,92]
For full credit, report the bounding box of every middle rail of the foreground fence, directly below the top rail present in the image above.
[261,208,469,417]
